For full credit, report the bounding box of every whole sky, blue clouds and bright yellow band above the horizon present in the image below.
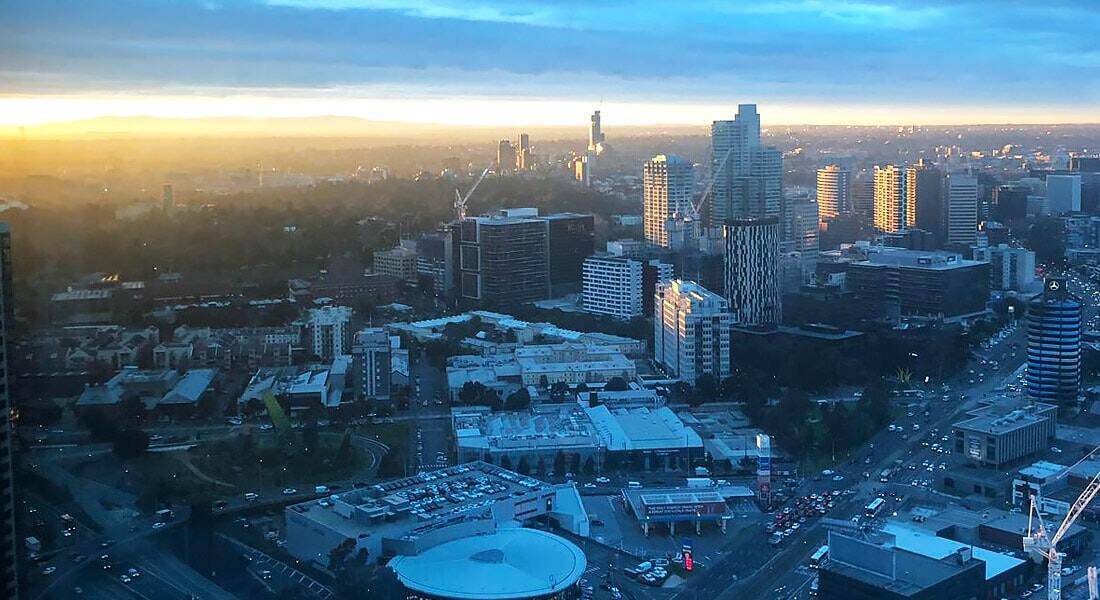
[0,0,1100,126]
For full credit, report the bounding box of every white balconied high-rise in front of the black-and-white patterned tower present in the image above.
[653,280,734,384]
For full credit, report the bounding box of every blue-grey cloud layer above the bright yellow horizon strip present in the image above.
[0,0,1100,113]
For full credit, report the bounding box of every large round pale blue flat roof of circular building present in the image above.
[389,528,587,600]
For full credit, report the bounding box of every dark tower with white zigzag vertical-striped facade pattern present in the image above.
[723,219,782,325]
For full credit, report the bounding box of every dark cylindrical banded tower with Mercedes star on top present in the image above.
[1024,277,1081,404]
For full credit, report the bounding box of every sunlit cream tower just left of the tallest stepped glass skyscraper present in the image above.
[641,154,695,248]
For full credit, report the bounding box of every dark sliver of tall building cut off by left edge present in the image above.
[0,222,19,600]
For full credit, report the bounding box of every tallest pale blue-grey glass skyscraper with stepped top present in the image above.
[707,105,784,227]
